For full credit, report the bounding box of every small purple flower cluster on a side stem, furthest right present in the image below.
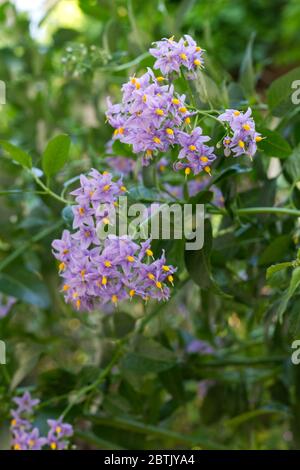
[218,108,262,158]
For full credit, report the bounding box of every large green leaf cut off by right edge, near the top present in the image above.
[267,67,300,116]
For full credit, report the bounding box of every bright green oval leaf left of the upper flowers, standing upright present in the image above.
[42,134,71,178]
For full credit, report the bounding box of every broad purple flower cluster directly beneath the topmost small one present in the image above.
[107,73,216,174]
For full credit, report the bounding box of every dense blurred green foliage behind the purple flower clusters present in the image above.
[0,0,300,449]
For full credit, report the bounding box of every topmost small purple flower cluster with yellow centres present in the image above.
[149,34,203,78]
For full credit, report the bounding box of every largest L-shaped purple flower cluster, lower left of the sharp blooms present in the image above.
[52,170,175,310]
